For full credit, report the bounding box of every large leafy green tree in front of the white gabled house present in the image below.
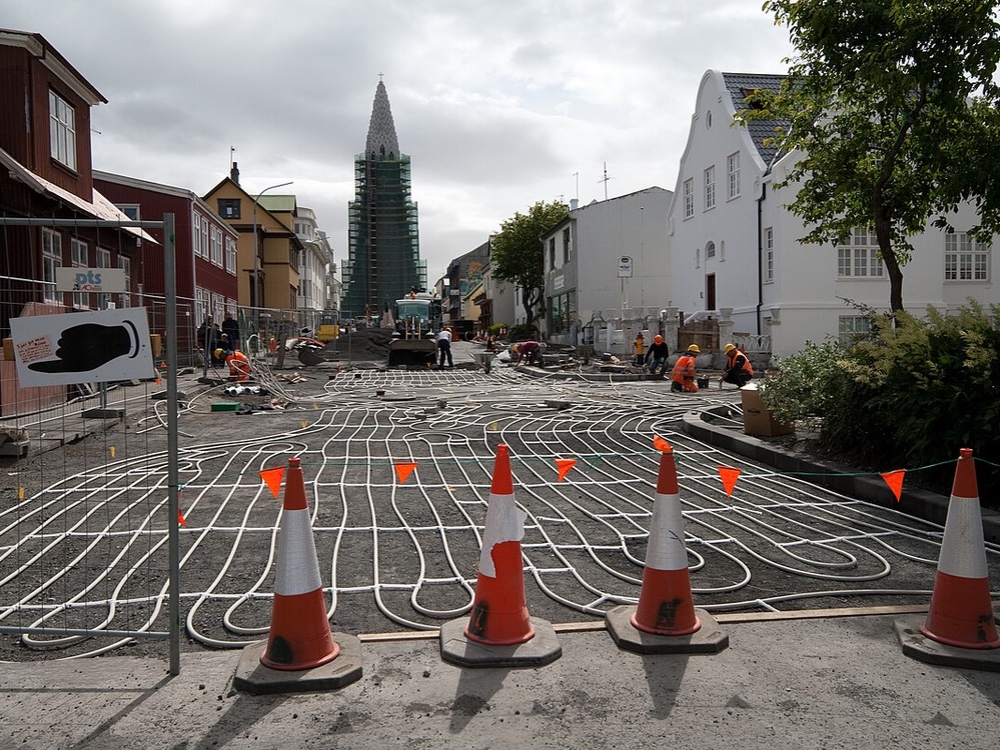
[739,0,1000,312]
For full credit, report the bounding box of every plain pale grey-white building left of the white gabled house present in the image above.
[542,187,673,352]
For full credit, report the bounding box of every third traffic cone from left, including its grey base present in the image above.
[606,445,729,653]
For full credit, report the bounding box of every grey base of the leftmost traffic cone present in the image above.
[233,633,361,695]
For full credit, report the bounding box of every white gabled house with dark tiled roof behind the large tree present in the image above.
[667,70,998,357]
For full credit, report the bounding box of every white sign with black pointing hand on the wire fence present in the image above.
[10,307,155,388]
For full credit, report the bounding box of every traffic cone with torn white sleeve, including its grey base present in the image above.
[441,445,562,667]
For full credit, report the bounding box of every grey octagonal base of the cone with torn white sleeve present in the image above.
[441,617,562,668]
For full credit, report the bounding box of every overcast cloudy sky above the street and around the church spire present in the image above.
[0,0,791,284]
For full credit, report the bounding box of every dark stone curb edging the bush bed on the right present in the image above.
[682,407,1000,543]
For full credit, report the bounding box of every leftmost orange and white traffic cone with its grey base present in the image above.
[234,458,361,693]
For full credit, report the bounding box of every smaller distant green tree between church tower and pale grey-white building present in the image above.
[490,201,569,326]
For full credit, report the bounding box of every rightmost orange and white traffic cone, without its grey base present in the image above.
[920,448,1000,649]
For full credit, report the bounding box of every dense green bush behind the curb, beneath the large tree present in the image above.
[761,302,1000,506]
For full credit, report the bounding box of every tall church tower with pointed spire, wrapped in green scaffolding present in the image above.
[341,80,427,317]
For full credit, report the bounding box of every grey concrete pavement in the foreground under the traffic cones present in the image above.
[0,615,1000,750]
